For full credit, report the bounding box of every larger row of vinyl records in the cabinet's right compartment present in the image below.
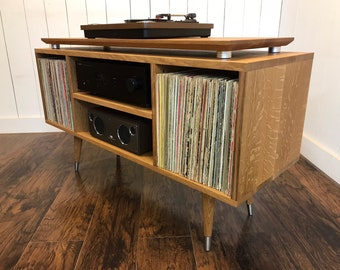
[156,71,238,195]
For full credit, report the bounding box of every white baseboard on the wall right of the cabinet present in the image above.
[301,134,340,184]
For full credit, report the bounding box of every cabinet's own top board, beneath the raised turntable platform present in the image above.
[35,48,313,73]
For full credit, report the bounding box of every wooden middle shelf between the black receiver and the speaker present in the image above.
[73,92,152,119]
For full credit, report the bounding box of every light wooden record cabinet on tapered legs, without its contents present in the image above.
[35,39,313,250]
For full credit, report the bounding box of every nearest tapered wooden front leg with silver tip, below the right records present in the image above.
[202,193,215,251]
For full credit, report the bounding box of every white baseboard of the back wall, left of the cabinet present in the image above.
[0,118,60,133]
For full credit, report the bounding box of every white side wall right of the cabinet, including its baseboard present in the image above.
[280,0,340,184]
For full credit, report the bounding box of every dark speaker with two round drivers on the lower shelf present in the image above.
[88,107,152,155]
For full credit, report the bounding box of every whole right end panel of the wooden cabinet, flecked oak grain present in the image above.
[234,60,312,200]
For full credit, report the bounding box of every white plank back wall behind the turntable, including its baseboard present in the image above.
[0,0,281,133]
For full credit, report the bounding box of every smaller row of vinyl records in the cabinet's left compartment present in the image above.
[38,58,73,130]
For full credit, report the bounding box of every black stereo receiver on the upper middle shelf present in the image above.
[76,59,151,108]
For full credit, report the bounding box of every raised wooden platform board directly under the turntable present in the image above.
[42,37,294,51]
